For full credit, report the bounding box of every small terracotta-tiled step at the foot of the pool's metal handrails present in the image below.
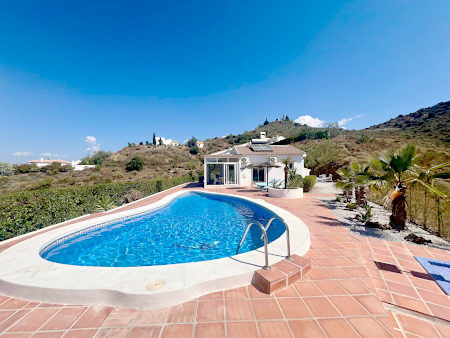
[252,255,311,294]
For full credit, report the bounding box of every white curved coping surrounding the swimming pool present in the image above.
[0,189,310,308]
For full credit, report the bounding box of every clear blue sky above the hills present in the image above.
[0,0,450,162]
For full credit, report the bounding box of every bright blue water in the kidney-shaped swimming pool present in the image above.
[41,192,285,267]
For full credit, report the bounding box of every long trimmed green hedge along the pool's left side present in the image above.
[0,176,191,240]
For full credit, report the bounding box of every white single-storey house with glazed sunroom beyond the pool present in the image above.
[204,134,310,187]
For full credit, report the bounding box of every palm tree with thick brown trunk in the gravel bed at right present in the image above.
[371,145,417,230]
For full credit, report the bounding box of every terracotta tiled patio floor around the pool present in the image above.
[0,188,450,338]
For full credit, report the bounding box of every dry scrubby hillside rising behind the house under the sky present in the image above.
[0,101,450,193]
